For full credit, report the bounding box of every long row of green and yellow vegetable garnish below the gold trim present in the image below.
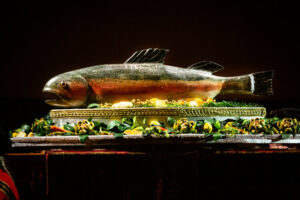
[10,117,300,141]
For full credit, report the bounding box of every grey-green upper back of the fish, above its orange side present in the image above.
[79,63,220,81]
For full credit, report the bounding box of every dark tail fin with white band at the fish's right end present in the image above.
[249,70,274,95]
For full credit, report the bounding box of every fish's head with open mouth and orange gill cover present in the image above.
[43,73,89,108]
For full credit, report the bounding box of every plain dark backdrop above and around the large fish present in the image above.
[0,0,300,129]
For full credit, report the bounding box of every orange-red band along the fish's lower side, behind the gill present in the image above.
[90,79,222,103]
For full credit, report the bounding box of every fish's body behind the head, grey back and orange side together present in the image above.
[79,64,223,102]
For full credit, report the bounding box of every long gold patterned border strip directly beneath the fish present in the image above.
[50,107,267,119]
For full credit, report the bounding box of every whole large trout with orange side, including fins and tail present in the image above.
[43,48,273,107]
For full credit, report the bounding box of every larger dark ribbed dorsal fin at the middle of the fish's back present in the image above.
[125,48,169,63]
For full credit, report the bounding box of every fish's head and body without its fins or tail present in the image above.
[43,64,226,107]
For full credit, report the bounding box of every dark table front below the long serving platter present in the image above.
[5,144,300,199]
